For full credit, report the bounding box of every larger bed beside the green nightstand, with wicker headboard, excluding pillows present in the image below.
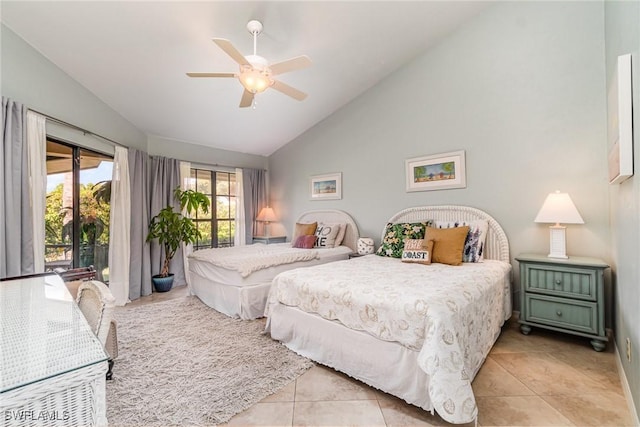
[265,206,512,424]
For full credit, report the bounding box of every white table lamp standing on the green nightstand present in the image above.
[534,191,584,258]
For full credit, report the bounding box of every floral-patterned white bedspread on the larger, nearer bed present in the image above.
[265,255,511,423]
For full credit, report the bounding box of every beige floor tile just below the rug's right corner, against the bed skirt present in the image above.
[296,365,377,402]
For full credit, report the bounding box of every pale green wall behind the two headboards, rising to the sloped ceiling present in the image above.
[269,2,610,308]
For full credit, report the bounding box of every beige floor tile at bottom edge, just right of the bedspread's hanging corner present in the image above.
[476,396,574,427]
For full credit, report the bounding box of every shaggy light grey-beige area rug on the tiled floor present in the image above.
[107,297,313,426]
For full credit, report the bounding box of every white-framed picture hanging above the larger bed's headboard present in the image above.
[405,151,467,191]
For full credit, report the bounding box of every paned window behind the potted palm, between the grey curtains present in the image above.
[191,169,236,250]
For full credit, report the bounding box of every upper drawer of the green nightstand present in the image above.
[522,264,597,301]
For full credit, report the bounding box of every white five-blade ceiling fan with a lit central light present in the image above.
[187,20,311,108]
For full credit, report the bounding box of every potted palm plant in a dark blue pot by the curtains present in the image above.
[147,187,209,292]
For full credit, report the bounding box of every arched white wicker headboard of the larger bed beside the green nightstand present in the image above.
[382,205,510,262]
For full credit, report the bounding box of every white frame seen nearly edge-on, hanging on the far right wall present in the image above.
[607,54,633,184]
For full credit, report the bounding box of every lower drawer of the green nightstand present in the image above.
[524,294,599,334]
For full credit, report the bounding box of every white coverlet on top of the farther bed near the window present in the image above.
[189,243,318,277]
